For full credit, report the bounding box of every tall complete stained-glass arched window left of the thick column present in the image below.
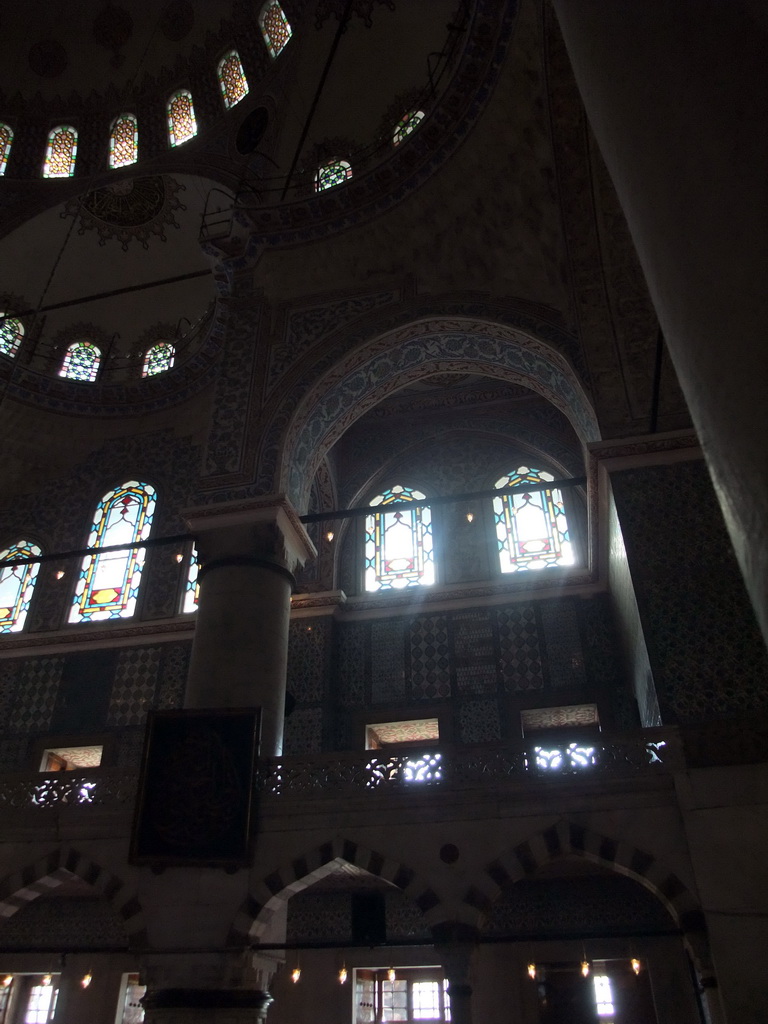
[70,480,156,623]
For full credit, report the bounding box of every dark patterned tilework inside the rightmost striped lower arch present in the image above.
[483,876,674,936]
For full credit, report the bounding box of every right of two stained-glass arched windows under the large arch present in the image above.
[494,466,573,572]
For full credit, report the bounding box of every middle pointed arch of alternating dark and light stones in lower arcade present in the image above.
[228,838,443,945]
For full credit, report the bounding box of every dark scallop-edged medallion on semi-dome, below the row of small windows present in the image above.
[61,174,186,251]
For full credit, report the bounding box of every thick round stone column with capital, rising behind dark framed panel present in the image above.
[185,495,315,757]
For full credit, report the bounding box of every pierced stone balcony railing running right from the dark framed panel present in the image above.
[256,729,678,797]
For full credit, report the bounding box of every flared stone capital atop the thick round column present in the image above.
[182,495,317,572]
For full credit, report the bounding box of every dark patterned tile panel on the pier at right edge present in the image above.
[611,462,768,723]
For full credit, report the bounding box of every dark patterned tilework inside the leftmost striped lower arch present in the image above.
[0,895,128,951]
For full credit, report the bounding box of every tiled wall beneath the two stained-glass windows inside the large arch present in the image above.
[285,596,639,754]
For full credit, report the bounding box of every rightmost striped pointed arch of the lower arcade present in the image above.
[464,821,703,933]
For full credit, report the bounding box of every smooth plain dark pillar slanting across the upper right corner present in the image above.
[553,0,768,638]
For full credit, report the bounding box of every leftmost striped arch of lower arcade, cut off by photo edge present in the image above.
[0,847,146,945]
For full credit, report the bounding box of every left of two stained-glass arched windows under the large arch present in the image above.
[365,484,434,592]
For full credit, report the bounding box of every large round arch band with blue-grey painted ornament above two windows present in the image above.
[275,317,600,509]
